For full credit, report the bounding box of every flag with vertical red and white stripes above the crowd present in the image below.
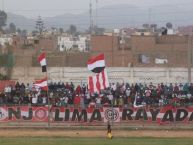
[88,69,109,93]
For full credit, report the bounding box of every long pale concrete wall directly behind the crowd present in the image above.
[5,67,193,84]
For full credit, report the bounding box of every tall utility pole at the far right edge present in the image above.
[187,31,192,83]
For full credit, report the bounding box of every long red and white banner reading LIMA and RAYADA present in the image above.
[0,106,193,125]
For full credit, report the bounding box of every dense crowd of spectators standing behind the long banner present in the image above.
[0,82,193,108]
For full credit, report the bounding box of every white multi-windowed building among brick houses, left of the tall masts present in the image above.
[58,36,88,51]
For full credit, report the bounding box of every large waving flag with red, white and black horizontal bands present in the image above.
[87,54,105,73]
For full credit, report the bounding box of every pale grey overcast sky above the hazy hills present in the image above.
[0,0,193,18]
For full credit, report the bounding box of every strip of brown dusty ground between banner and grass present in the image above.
[0,129,193,138]
